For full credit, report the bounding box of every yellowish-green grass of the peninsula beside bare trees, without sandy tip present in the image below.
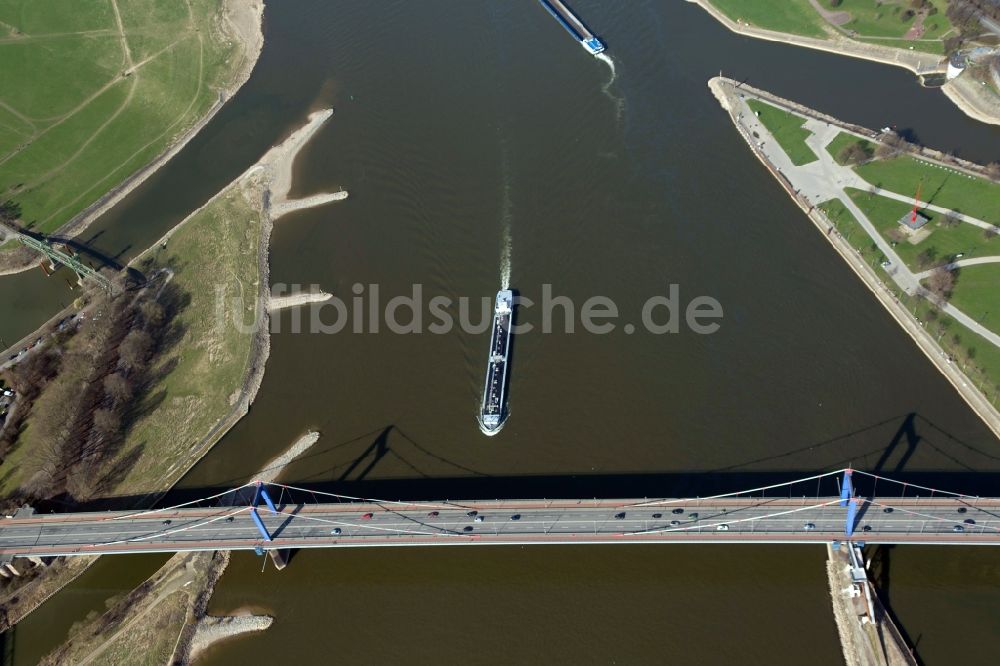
[111,179,260,492]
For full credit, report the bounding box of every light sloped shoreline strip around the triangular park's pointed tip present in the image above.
[708,77,1000,438]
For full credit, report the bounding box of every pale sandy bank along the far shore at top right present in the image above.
[687,0,1000,125]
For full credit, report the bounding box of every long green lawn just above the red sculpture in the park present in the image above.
[855,155,1000,224]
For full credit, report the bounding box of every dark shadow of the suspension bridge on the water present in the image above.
[60,413,1000,511]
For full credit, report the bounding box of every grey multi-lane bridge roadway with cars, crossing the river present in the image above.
[0,497,1000,558]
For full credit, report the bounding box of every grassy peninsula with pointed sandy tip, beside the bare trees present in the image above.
[119,109,347,495]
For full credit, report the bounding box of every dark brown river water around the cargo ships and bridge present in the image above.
[0,0,1000,664]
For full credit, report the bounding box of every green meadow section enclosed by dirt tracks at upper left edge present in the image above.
[0,36,124,119]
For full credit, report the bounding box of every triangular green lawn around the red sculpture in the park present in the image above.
[845,188,1000,272]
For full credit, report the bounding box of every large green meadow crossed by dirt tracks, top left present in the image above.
[0,0,239,232]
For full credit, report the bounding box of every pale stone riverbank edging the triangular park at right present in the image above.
[708,77,1000,438]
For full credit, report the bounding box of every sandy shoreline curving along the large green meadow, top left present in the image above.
[0,0,264,276]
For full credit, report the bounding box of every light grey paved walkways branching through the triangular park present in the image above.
[736,93,1000,347]
